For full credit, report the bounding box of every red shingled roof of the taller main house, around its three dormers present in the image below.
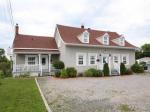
[57,25,135,48]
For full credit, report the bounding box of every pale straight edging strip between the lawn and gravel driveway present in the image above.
[35,78,52,112]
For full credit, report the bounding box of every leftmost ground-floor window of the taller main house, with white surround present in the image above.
[76,53,86,66]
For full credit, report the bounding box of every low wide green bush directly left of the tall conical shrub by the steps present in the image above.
[84,68,102,77]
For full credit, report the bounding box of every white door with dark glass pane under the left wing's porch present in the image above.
[41,55,48,71]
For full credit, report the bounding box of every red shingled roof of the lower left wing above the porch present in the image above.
[13,34,58,49]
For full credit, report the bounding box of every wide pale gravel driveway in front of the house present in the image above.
[38,74,150,112]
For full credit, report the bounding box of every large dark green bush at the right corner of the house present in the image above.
[131,62,144,73]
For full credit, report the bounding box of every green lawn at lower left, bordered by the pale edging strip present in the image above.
[0,78,46,112]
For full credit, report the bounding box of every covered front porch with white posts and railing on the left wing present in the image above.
[13,53,59,76]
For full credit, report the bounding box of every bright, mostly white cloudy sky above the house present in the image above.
[0,0,150,49]
